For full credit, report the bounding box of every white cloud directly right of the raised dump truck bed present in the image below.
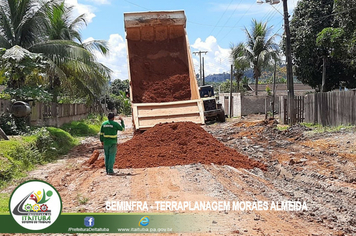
[191,36,231,76]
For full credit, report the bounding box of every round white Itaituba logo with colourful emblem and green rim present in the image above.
[9,180,62,230]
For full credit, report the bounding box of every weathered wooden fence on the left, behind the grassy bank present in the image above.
[0,99,106,127]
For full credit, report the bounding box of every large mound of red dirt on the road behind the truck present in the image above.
[92,122,266,170]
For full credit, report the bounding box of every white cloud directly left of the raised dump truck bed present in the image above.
[84,34,128,80]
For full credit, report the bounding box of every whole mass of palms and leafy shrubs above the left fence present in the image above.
[0,0,111,104]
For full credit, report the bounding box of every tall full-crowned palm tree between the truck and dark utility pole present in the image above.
[231,19,278,95]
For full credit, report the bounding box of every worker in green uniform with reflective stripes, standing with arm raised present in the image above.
[100,112,125,175]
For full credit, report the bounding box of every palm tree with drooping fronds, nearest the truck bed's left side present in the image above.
[40,2,111,100]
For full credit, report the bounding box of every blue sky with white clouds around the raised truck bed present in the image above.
[65,0,298,80]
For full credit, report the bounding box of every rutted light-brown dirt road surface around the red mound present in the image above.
[5,118,356,235]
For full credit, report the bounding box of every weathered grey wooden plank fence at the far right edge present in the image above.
[305,90,356,126]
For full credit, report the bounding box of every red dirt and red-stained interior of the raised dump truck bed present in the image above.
[128,37,191,103]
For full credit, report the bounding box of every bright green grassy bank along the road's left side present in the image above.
[0,115,105,213]
